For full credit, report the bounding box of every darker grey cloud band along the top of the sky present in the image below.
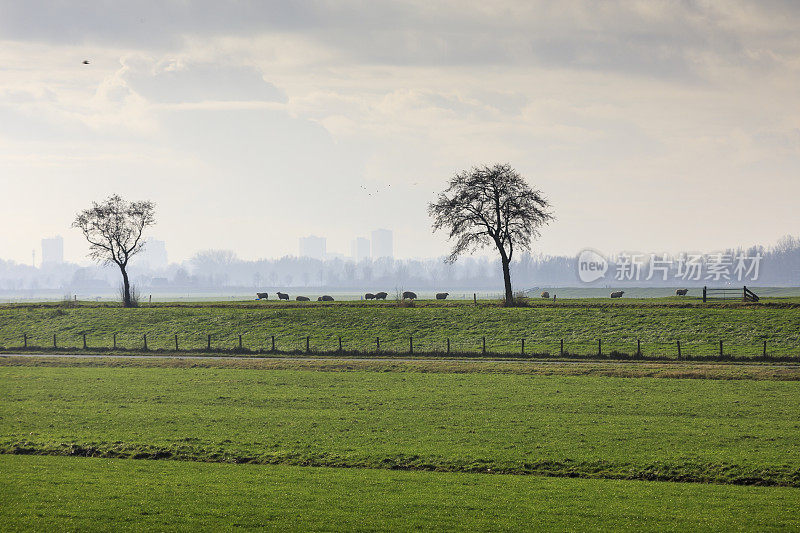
[0,0,800,78]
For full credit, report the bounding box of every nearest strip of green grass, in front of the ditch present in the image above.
[0,456,800,531]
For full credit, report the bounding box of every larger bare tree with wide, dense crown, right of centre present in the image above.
[428,165,553,305]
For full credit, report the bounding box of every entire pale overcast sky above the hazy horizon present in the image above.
[0,0,800,262]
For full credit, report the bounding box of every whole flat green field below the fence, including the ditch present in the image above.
[0,357,800,531]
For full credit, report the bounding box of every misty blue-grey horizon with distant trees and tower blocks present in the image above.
[0,230,800,300]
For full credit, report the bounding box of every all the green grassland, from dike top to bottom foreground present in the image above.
[0,298,800,531]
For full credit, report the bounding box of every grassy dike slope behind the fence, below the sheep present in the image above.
[0,302,800,358]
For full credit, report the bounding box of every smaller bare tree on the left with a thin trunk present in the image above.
[72,195,156,307]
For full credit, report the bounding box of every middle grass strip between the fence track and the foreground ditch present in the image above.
[0,366,800,486]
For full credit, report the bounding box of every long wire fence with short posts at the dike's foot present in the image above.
[0,332,800,362]
